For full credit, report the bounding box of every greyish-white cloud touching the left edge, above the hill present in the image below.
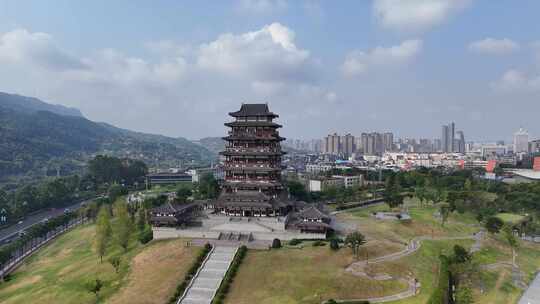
[0,29,85,71]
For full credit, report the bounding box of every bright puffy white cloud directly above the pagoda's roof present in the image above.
[197,23,314,82]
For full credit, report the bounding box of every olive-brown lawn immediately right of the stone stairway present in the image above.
[226,245,407,304]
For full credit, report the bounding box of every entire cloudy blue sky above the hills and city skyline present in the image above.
[0,0,540,140]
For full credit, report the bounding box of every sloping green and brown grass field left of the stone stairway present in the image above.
[0,225,196,304]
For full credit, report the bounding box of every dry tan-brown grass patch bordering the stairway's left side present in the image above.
[109,240,199,304]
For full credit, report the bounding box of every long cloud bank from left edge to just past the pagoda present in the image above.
[0,23,338,137]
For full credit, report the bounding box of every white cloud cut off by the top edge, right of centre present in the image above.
[373,0,472,31]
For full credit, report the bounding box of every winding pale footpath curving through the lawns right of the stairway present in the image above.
[334,230,484,303]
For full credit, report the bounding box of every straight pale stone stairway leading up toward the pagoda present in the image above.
[177,246,238,304]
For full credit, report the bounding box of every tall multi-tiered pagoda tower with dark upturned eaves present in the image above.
[215,104,290,216]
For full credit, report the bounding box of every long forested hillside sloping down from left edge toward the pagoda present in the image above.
[0,94,214,183]
